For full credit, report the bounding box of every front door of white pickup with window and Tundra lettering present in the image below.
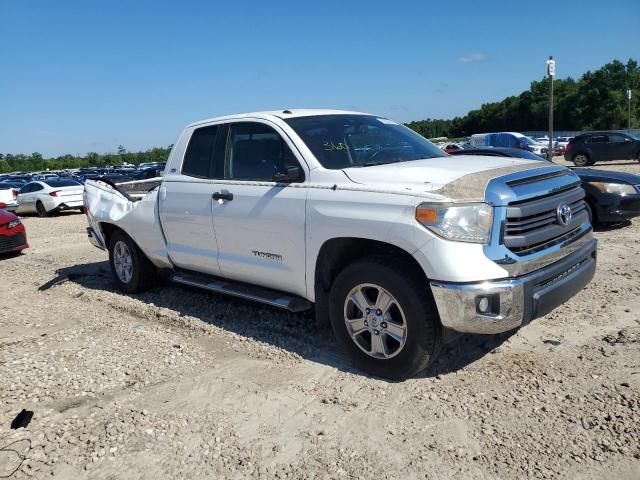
[213,121,307,295]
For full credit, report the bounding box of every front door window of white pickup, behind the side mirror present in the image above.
[224,122,304,182]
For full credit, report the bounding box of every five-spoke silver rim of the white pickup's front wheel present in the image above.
[344,283,407,360]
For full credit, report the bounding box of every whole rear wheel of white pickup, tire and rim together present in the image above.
[109,231,156,293]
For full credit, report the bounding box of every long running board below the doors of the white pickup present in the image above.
[171,273,311,312]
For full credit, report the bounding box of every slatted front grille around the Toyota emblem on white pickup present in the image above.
[503,186,589,255]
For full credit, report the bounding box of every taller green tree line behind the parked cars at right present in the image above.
[407,59,640,138]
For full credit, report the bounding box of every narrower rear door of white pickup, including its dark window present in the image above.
[158,125,225,275]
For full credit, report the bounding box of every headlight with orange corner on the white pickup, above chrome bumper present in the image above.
[416,203,493,243]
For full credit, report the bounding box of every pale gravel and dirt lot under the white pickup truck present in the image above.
[0,159,640,479]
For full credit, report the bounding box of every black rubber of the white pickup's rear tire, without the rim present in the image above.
[109,230,157,293]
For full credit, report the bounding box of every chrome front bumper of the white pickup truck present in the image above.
[431,238,597,334]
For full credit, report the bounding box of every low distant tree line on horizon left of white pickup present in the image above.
[0,145,173,173]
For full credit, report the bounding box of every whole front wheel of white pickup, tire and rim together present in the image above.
[329,256,442,379]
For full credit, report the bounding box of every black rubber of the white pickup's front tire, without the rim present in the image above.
[329,256,442,380]
